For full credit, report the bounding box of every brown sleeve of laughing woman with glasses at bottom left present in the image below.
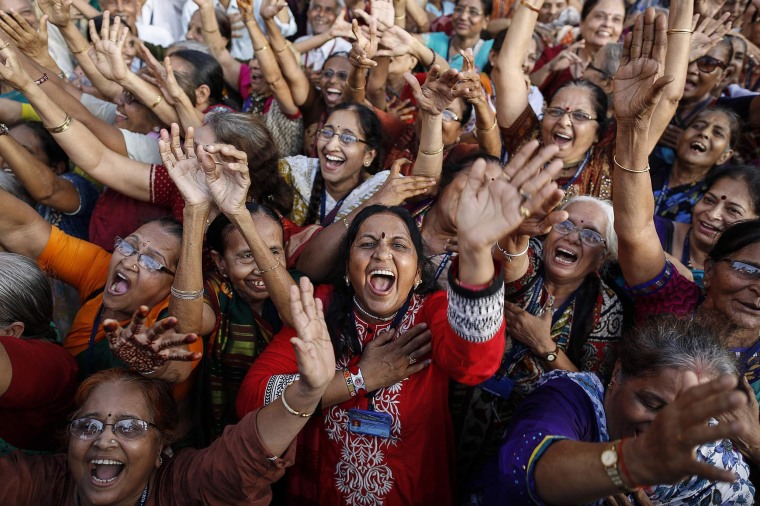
[165,411,295,504]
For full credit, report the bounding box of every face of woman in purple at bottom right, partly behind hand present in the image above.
[604,365,713,439]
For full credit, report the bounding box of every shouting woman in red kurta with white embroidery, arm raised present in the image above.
[237,148,559,505]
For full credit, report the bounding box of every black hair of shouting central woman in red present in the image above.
[325,205,438,359]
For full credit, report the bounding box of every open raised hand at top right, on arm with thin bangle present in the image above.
[614,7,673,127]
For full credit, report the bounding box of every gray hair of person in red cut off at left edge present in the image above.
[0,253,55,338]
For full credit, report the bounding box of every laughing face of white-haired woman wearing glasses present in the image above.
[544,202,607,283]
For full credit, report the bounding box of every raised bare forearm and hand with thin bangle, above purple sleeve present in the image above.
[612,9,672,286]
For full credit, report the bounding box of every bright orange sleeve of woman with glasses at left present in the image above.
[37,227,111,299]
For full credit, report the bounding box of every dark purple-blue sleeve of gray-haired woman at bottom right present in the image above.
[477,377,598,505]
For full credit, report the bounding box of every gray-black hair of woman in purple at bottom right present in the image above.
[618,315,736,381]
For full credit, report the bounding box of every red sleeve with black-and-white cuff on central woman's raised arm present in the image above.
[425,259,505,385]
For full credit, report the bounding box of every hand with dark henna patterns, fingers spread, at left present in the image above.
[103,306,201,374]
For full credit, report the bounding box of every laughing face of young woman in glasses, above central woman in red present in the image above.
[317,110,375,189]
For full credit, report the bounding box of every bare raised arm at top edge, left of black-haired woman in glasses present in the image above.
[492,0,544,128]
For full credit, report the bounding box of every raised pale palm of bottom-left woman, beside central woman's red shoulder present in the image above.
[290,277,335,396]
